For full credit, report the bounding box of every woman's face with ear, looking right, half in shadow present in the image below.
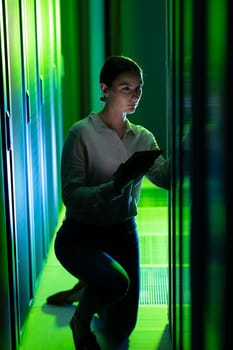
[101,72,143,114]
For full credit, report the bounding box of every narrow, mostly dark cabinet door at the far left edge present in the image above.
[0,2,17,350]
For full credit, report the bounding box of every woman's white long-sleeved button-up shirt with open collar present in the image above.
[61,114,170,226]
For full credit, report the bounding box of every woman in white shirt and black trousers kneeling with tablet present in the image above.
[55,56,169,350]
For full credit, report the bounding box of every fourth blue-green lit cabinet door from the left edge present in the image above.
[36,1,59,248]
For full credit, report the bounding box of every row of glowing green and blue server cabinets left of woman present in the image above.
[0,0,63,349]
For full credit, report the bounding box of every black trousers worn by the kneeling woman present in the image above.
[55,218,140,339]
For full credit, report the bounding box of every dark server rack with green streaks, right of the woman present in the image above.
[168,0,232,350]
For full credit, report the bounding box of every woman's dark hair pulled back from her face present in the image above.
[100,56,142,86]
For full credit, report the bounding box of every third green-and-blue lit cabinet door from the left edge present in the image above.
[21,0,46,288]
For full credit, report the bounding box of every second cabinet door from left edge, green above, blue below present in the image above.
[3,0,31,334]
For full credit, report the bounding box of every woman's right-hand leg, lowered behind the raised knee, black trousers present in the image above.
[99,220,140,342]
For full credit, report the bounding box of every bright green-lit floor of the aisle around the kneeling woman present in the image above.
[19,180,171,350]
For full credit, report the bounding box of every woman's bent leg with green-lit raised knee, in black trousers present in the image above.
[55,220,129,340]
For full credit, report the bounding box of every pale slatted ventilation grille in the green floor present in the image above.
[140,267,168,305]
